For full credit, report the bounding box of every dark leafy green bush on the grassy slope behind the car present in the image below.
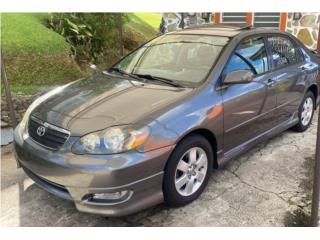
[48,13,127,64]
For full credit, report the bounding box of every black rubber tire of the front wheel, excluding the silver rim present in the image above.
[163,134,213,207]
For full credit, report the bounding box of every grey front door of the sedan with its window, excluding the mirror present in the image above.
[222,36,276,152]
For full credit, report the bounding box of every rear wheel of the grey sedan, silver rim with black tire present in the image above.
[292,91,316,132]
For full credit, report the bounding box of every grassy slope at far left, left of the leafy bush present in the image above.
[1,13,84,89]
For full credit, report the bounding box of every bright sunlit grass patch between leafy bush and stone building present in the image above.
[126,13,161,39]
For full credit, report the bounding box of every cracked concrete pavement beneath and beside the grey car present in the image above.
[1,115,317,226]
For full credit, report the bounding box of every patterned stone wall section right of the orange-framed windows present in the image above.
[286,12,320,49]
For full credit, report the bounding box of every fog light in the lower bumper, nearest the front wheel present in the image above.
[83,190,133,205]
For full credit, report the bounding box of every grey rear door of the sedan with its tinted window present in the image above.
[267,34,307,124]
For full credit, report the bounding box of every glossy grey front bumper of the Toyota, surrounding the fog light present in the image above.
[14,126,173,216]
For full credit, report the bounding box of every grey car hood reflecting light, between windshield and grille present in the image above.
[32,72,192,135]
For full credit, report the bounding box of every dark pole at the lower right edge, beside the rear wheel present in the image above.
[311,107,320,227]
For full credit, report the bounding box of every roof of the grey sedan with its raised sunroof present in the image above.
[168,24,283,38]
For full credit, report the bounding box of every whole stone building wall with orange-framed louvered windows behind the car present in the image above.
[163,12,320,51]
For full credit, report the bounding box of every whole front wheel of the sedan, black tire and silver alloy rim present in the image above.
[163,134,213,207]
